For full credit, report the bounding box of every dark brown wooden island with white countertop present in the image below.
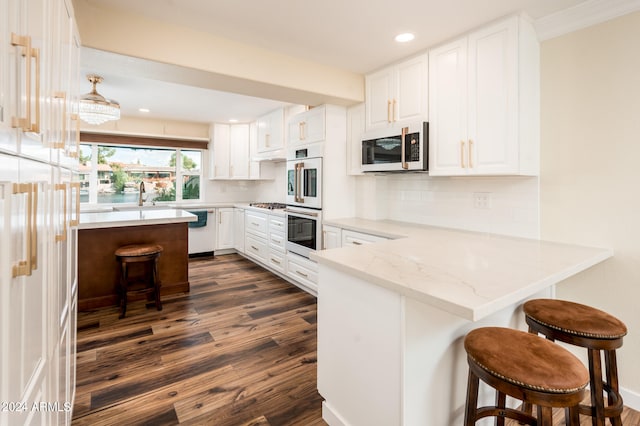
[78,209,197,311]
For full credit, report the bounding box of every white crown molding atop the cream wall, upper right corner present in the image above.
[535,0,640,41]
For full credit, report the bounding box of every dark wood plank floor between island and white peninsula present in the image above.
[73,255,326,426]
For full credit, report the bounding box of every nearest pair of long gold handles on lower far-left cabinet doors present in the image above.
[11,183,38,278]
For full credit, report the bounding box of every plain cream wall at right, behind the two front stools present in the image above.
[540,13,640,409]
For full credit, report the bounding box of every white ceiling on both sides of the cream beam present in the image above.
[77,0,584,122]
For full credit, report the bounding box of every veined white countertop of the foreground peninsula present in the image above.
[311,218,613,321]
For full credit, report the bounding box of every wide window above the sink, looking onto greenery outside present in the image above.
[80,143,202,204]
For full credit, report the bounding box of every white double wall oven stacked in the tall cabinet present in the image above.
[286,145,322,258]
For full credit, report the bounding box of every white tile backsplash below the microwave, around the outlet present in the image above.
[356,173,539,238]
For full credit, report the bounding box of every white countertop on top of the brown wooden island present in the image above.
[78,208,197,229]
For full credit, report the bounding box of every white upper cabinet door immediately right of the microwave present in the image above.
[429,38,469,176]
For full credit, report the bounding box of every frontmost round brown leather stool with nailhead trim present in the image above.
[464,327,589,426]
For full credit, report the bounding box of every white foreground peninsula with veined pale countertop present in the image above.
[312,219,613,426]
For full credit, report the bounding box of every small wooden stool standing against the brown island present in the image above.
[115,244,162,318]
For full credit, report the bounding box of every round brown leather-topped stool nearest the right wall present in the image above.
[523,299,627,426]
